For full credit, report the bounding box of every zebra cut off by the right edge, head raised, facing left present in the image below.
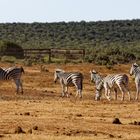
[130,63,140,100]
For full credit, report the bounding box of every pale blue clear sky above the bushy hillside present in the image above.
[0,0,140,23]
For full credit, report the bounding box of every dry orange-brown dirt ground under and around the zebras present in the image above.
[0,63,140,140]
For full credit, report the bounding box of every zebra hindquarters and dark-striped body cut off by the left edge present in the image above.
[0,67,24,94]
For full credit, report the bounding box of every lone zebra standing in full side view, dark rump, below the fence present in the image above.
[54,69,83,98]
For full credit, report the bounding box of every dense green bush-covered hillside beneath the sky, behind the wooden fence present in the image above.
[0,19,140,64]
